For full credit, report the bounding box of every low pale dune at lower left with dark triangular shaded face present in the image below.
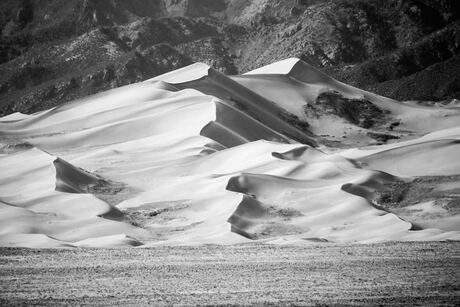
[0,148,145,247]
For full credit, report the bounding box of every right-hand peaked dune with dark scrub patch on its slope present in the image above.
[231,58,460,146]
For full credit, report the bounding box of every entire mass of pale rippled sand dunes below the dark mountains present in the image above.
[0,59,460,248]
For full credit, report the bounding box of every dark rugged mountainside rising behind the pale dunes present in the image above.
[0,0,460,115]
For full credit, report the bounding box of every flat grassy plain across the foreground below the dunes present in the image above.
[0,242,460,306]
